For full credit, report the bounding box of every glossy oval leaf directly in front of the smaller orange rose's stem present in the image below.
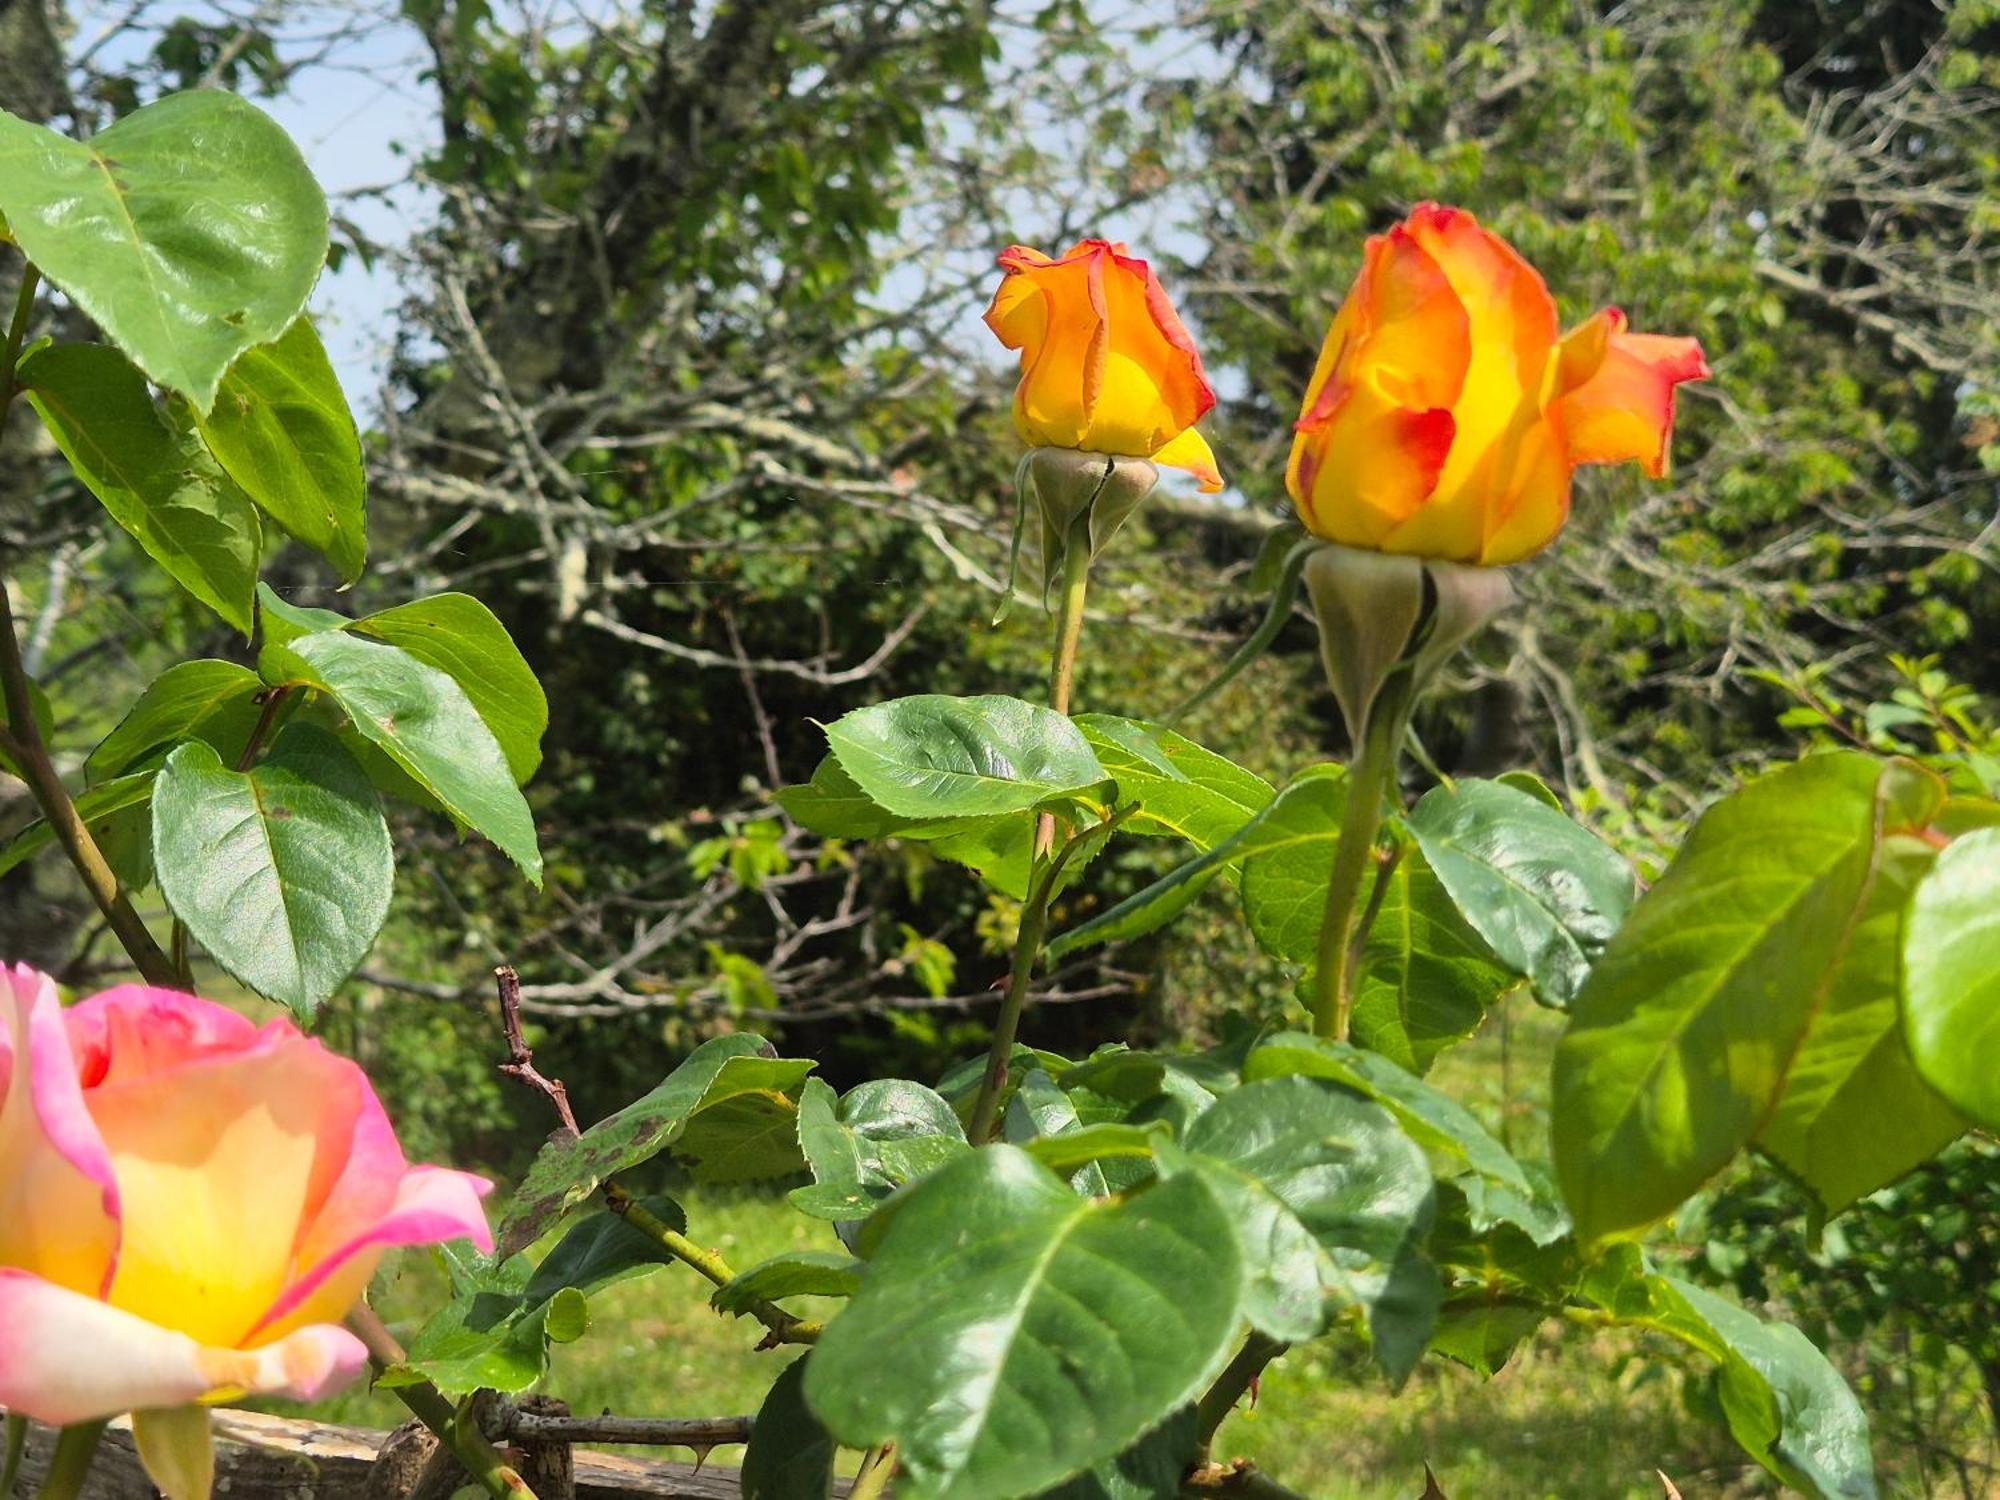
[826,694,1104,818]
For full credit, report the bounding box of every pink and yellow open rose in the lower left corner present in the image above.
[0,968,492,1488]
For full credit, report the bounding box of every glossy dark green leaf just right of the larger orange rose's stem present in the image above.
[1408,780,1634,1006]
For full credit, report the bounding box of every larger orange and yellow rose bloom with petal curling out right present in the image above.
[1286,204,1708,566]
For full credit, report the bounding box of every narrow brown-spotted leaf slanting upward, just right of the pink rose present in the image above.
[496,1032,812,1256]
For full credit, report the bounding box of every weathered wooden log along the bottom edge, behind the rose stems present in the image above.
[0,1410,788,1500]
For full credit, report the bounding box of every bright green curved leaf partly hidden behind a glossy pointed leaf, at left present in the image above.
[348,594,548,782]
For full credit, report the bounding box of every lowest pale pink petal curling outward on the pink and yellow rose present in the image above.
[0,1268,368,1424]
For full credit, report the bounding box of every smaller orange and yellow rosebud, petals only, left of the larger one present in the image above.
[986,240,1222,492]
